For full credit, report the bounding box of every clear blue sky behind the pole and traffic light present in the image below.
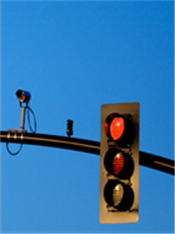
[0,0,175,234]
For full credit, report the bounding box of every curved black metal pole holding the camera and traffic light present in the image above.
[0,130,175,175]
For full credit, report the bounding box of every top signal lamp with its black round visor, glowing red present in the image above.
[104,113,135,147]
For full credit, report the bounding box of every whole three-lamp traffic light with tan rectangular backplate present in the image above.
[100,103,139,223]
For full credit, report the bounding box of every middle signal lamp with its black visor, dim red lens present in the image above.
[104,148,134,179]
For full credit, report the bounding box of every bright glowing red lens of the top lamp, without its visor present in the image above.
[109,117,125,141]
